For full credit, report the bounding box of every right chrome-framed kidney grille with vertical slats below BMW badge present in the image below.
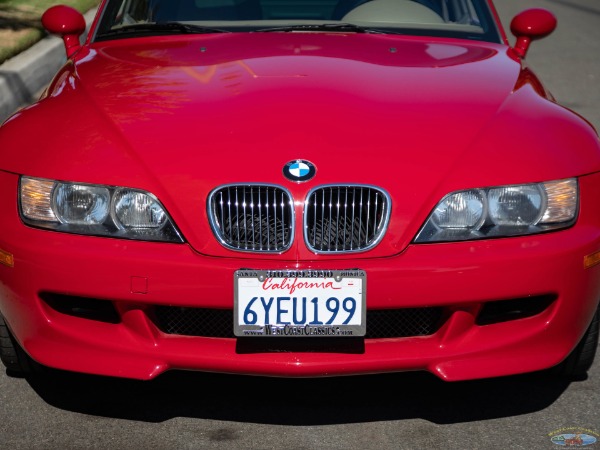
[304,186,390,253]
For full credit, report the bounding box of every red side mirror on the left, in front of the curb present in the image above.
[42,5,86,58]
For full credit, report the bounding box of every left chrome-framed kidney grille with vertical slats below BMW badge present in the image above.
[208,185,294,253]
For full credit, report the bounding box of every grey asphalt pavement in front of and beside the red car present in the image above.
[0,0,600,450]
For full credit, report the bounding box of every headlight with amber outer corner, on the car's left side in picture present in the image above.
[19,177,183,242]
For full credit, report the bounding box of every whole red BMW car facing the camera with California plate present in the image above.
[0,0,600,380]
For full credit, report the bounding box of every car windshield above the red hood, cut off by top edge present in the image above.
[95,0,501,42]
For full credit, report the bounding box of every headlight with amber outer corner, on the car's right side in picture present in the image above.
[415,179,579,242]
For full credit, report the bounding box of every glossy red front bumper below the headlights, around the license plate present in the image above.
[0,172,600,380]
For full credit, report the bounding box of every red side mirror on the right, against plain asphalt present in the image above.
[510,8,556,58]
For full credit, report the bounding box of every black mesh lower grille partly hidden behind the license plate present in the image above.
[155,306,443,339]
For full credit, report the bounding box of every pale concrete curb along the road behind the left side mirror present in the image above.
[0,9,96,123]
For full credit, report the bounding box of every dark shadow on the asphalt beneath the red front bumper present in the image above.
[23,370,569,426]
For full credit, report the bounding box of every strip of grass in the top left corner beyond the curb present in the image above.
[0,0,100,64]
